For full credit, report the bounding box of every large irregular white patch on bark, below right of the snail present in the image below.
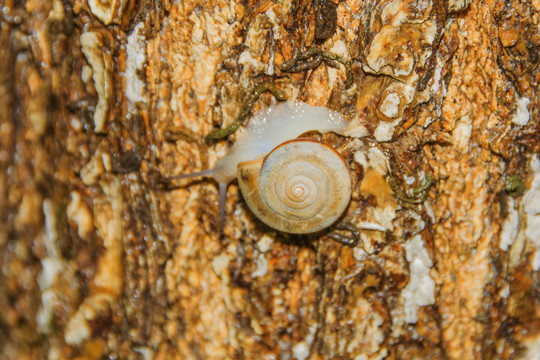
[401,235,435,324]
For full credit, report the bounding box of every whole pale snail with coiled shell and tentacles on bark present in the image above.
[168,101,352,234]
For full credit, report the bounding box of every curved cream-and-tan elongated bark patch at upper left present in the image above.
[80,31,113,133]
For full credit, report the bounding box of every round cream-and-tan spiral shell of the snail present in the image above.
[238,139,352,234]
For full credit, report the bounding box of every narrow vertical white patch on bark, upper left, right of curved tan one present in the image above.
[125,22,146,104]
